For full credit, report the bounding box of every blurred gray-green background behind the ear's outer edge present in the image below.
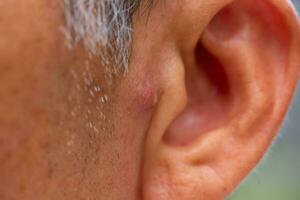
[228,0,300,200]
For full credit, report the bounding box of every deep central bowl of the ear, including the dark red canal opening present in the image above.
[164,40,233,145]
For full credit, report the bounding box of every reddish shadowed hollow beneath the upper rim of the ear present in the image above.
[204,0,291,53]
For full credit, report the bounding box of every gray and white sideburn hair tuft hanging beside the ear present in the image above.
[64,0,139,72]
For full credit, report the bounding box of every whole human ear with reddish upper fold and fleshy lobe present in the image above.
[141,0,300,200]
